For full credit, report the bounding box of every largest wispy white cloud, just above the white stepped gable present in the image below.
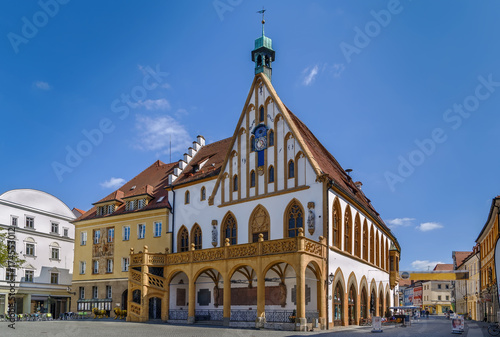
[134,115,192,154]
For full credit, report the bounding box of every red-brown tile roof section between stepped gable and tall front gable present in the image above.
[173,137,232,186]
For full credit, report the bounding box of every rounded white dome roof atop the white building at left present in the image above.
[0,189,75,219]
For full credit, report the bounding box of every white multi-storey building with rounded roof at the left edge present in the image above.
[0,189,76,317]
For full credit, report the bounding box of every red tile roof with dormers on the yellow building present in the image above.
[75,160,178,222]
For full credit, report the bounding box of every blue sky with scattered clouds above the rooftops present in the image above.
[0,0,500,270]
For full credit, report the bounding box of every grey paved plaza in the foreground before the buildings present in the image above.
[0,317,489,337]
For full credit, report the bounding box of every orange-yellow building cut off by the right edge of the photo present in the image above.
[476,196,500,322]
